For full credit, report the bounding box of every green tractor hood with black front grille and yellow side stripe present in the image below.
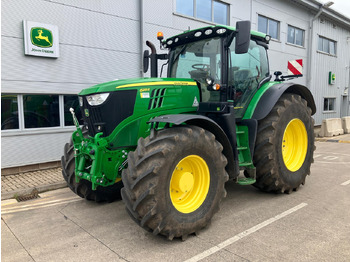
[79,78,200,139]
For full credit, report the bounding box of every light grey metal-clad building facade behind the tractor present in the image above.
[1,0,350,168]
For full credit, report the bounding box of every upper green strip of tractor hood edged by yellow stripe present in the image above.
[79,78,197,96]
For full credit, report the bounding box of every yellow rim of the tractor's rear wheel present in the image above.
[282,118,307,172]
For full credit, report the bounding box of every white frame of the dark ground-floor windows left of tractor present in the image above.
[1,92,82,136]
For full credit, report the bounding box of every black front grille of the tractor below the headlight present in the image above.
[81,90,137,137]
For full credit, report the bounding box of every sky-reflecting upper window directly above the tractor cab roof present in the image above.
[176,0,229,25]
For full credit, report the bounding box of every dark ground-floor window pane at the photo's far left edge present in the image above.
[1,94,19,130]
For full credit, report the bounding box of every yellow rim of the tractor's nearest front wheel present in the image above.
[169,155,210,214]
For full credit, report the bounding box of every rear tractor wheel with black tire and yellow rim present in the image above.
[254,94,315,193]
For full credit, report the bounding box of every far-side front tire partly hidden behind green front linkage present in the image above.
[61,129,123,202]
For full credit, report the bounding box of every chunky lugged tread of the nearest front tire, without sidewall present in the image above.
[121,126,228,240]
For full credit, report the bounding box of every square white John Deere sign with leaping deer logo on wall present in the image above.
[23,21,59,57]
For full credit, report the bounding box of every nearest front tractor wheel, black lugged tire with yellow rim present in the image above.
[122,126,228,240]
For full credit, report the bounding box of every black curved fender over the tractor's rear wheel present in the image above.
[252,83,316,120]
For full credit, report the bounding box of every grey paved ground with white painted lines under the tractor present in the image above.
[1,138,350,262]
